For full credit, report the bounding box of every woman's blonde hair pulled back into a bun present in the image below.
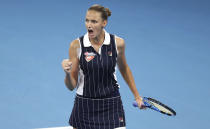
[88,4,112,20]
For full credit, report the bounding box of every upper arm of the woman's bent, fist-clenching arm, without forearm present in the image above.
[69,40,80,81]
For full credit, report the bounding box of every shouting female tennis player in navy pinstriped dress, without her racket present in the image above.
[62,5,144,129]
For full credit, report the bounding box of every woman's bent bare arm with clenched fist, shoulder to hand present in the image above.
[62,40,80,91]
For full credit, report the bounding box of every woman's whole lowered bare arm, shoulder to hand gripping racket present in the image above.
[116,37,143,108]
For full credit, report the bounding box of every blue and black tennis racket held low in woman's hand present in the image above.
[133,97,176,116]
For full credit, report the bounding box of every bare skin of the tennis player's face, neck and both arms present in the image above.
[62,10,145,129]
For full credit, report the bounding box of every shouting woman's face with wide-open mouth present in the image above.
[85,10,107,39]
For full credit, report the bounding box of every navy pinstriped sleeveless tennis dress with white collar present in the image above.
[69,32,125,129]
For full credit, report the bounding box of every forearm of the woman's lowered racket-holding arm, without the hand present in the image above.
[121,66,140,98]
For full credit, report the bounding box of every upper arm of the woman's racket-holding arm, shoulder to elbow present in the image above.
[116,37,127,72]
